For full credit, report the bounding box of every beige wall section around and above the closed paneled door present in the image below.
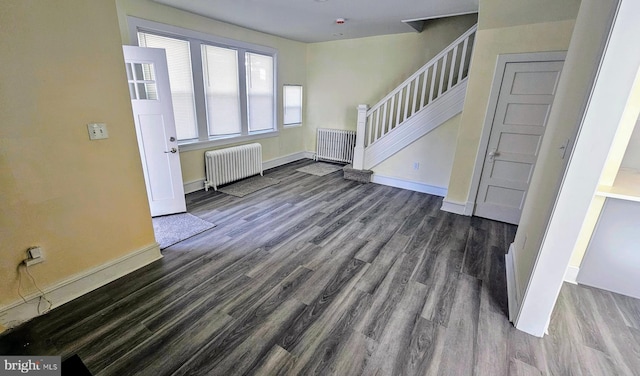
[446,0,577,204]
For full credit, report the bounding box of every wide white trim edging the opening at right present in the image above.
[515,0,640,336]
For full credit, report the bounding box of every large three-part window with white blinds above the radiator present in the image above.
[129,17,277,150]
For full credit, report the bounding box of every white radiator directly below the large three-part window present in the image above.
[204,143,262,191]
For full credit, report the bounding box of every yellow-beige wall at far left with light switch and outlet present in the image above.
[0,0,155,306]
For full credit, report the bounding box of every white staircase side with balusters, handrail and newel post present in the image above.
[353,25,477,170]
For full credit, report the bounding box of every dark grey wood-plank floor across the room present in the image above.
[0,160,640,376]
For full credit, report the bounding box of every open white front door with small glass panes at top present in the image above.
[123,46,186,217]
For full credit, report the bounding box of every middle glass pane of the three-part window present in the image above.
[202,45,242,136]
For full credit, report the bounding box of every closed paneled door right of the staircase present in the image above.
[474,61,564,224]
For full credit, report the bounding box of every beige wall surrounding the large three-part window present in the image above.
[116,0,308,183]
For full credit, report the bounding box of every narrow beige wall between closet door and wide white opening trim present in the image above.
[514,0,628,289]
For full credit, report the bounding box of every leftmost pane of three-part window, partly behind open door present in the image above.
[138,32,198,140]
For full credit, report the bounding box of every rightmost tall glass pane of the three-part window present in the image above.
[245,52,274,132]
